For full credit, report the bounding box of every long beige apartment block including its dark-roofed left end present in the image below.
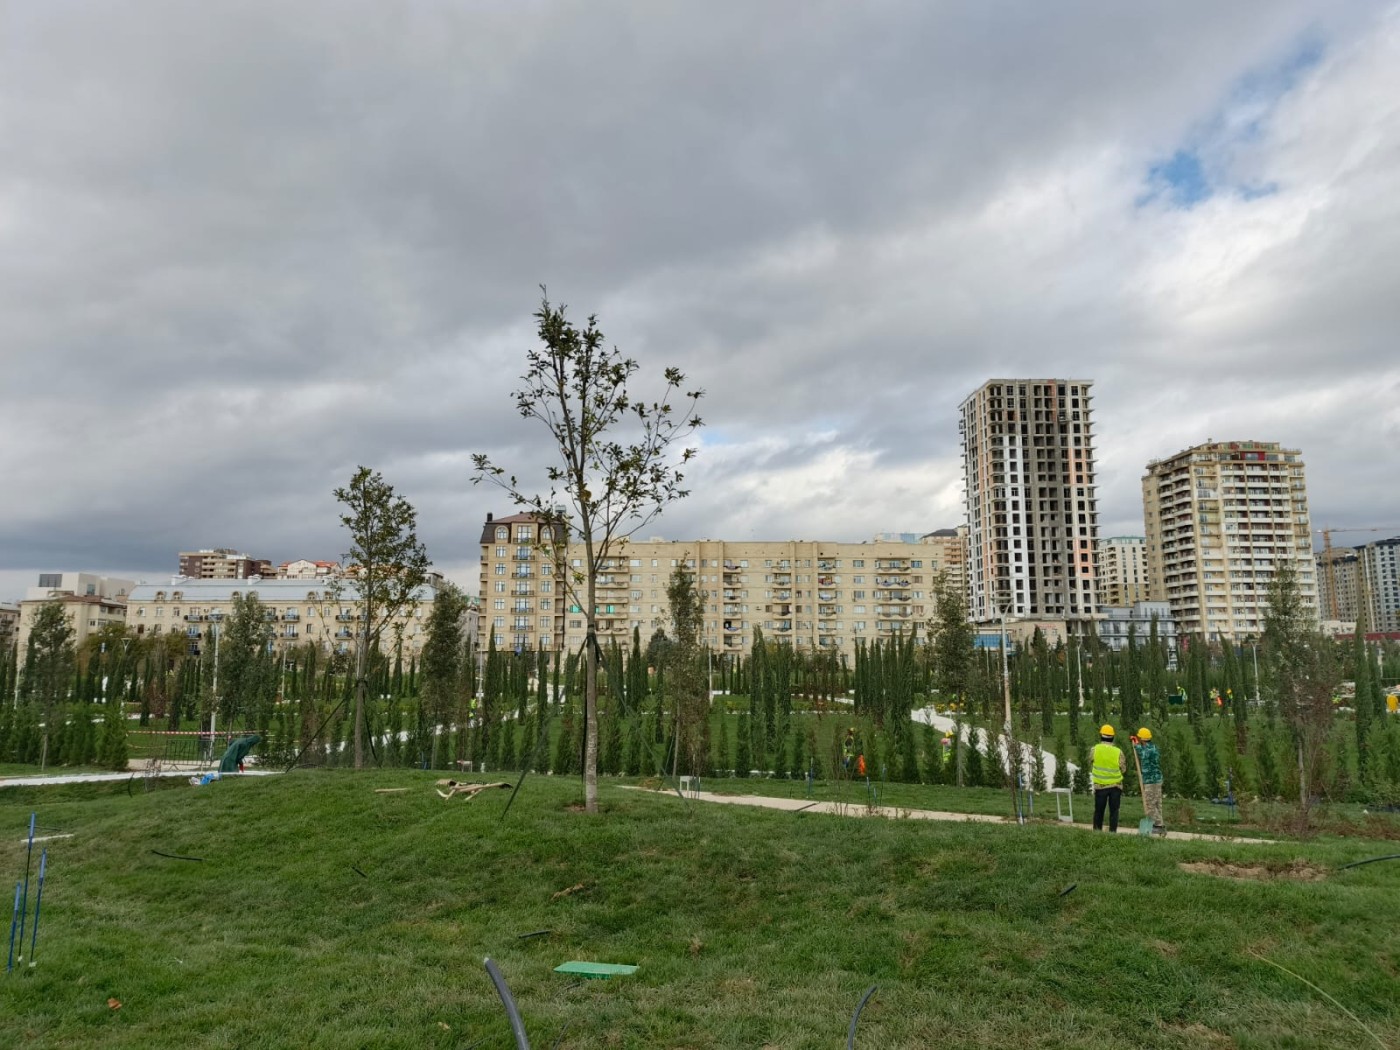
[477,515,960,659]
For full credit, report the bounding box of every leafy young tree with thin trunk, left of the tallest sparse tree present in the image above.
[335,466,433,770]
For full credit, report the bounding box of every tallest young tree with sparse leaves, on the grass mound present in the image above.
[472,298,703,812]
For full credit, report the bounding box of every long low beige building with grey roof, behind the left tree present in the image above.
[126,577,435,658]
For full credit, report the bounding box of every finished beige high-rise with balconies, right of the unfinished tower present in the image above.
[1142,441,1317,641]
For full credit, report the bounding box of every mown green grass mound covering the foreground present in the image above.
[0,770,1400,1050]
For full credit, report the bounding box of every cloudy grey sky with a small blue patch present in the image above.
[0,0,1400,599]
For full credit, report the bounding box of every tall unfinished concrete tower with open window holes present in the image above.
[958,379,1099,634]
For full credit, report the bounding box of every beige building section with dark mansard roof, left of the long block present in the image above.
[477,514,567,652]
